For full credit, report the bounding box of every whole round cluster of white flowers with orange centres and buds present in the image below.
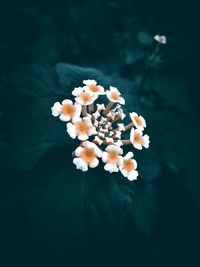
[51,80,150,181]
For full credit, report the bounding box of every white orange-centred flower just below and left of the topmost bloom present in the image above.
[72,87,98,106]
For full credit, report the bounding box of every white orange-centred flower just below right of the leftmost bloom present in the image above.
[67,117,97,141]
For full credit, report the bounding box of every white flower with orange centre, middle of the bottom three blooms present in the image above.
[102,145,123,173]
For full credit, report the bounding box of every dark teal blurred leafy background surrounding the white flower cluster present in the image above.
[0,0,200,267]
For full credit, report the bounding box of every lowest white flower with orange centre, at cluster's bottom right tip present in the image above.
[119,152,138,181]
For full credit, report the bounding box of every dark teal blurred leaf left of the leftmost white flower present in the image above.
[0,65,71,170]
